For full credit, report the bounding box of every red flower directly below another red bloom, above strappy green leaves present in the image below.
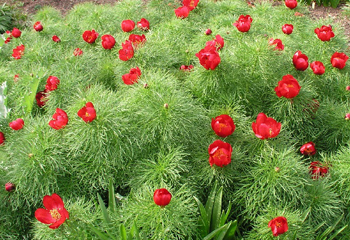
[208,140,232,167]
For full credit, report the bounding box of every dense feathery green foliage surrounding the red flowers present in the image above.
[0,0,350,239]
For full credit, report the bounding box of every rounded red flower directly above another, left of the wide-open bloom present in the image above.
[211,114,236,137]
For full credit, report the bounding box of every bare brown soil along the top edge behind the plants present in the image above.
[0,0,350,47]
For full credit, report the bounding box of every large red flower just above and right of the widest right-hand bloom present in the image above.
[275,74,301,98]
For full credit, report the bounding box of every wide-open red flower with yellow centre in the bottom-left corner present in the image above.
[35,193,69,229]
